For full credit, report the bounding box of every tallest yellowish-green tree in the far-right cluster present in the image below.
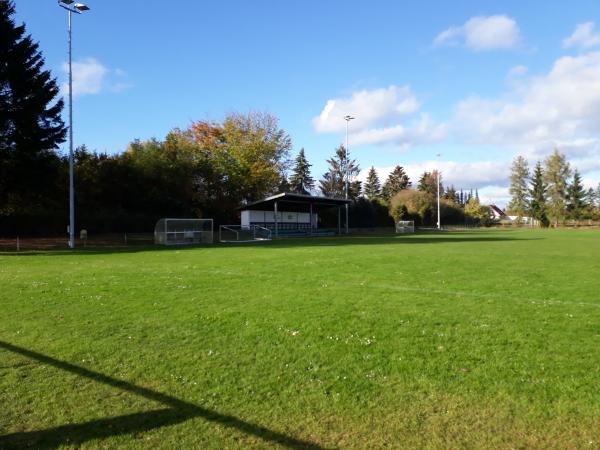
[544,149,571,226]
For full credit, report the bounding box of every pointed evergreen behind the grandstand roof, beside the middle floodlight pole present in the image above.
[319,145,361,200]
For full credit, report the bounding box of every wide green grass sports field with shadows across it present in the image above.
[0,230,600,449]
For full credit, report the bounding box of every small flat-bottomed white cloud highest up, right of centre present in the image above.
[433,15,521,51]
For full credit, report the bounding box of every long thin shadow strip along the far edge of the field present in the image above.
[0,231,545,256]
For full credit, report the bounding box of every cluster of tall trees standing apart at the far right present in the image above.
[507,149,600,227]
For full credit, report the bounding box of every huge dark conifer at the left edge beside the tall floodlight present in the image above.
[0,0,66,215]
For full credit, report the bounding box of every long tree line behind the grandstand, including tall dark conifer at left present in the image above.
[0,0,489,235]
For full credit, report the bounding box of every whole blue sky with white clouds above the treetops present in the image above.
[15,0,600,204]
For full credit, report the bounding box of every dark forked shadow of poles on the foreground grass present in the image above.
[0,341,322,449]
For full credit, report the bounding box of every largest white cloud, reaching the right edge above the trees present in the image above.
[453,52,600,161]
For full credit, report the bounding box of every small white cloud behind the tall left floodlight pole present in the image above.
[61,58,131,96]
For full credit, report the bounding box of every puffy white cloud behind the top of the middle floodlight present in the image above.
[313,85,445,147]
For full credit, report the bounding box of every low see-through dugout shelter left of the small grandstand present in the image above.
[154,218,213,245]
